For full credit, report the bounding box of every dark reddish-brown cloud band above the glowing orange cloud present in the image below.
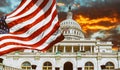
[71,0,120,18]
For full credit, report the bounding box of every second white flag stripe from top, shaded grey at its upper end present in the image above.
[6,0,43,24]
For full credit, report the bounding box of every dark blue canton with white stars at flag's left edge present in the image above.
[0,16,9,34]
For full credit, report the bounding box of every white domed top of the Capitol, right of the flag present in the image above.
[60,12,84,40]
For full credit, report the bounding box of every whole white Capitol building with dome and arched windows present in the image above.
[0,12,120,70]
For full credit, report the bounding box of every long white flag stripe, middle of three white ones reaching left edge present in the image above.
[0,17,58,45]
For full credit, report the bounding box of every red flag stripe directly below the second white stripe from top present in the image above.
[8,0,49,28]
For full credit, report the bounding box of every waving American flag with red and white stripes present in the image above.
[0,0,64,56]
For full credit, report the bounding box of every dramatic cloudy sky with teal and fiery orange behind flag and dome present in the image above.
[0,0,120,47]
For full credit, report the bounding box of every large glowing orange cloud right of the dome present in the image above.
[75,15,118,32]
